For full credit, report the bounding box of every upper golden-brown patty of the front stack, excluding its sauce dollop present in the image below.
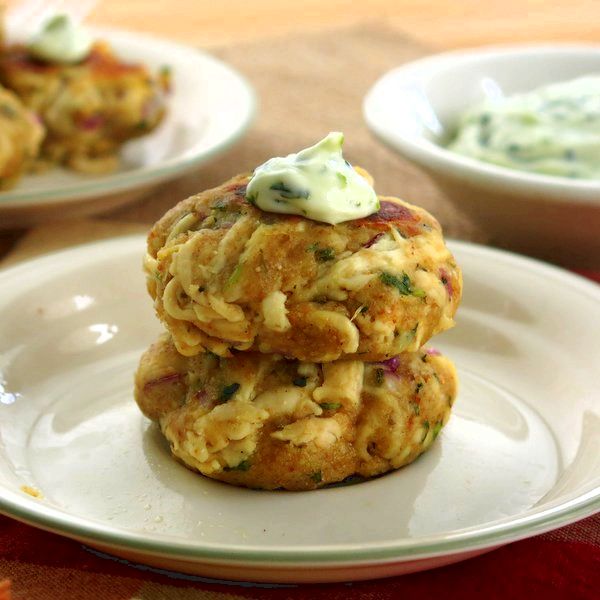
[145,172,462,362]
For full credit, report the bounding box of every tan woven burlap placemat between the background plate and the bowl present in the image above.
[0,23,483,264]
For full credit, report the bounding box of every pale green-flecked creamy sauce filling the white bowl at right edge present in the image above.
[448,76,600,179]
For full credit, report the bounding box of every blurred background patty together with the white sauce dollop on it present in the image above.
[0,15,169,173]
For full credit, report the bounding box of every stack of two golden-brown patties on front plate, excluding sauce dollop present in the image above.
[135,175,462,490]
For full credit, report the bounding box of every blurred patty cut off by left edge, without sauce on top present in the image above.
[0,86,44,190]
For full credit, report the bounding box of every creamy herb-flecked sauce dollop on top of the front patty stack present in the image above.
[246,132,379,225]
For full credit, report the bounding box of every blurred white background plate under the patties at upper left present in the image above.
[0,29,255,228]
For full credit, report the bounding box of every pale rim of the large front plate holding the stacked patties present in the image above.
[0,234,600,569]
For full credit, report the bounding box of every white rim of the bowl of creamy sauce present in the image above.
[363,43,600,206]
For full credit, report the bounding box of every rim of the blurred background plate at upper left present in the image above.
[0,27,258,215]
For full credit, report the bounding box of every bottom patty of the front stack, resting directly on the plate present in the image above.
[135,334,457,490]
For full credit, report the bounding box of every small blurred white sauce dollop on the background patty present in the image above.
[27,15,93,64]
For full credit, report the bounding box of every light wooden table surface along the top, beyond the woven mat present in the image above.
[91,0,600,48]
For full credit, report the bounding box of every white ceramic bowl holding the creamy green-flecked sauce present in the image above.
[363,45,600,268]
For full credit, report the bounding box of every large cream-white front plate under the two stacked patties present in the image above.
[0,236,600,581]
